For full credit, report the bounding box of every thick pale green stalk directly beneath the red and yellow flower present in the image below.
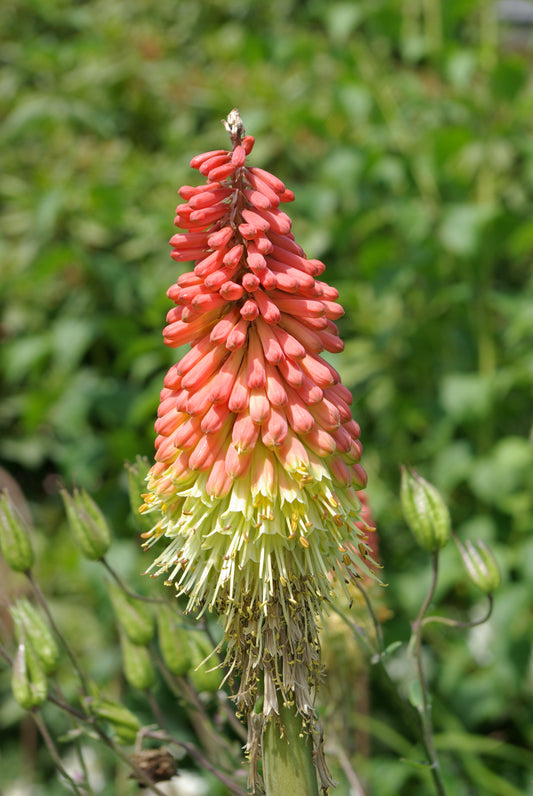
[263,707,318,796]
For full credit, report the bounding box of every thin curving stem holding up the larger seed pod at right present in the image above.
[410,550,446,796]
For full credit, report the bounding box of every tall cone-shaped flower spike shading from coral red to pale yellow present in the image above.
[143,111,374,784]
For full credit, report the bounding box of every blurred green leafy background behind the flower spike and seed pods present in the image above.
[0,0,533,796]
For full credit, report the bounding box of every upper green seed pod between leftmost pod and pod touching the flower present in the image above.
[61,489,111,561]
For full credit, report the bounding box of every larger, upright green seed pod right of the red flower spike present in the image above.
[400,467,451,553]
